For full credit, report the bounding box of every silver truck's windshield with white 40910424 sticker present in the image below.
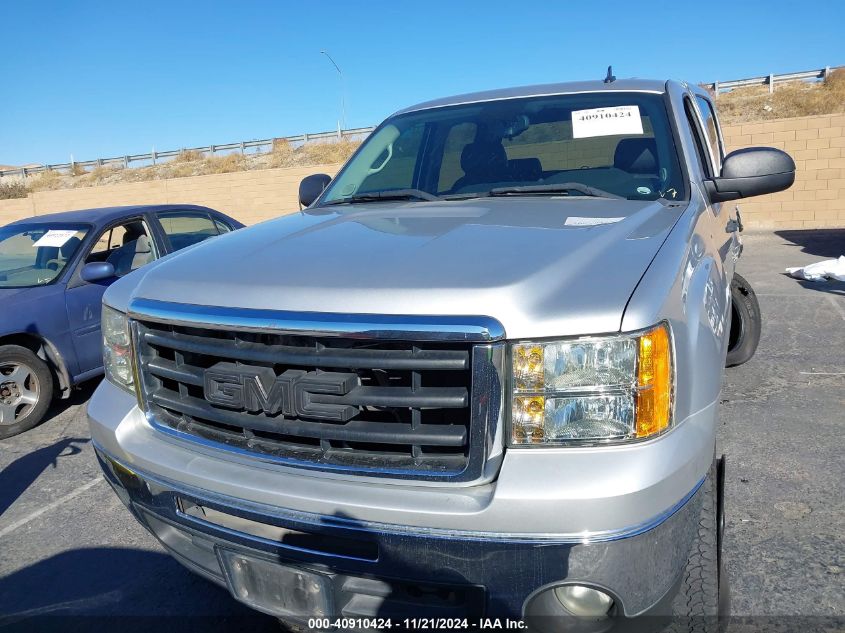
[320,92,685,204]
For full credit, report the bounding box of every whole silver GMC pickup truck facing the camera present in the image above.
[88,77,795,631]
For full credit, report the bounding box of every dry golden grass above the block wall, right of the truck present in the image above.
[716,70,845,125]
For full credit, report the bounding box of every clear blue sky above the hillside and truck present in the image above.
[0,0,845,164]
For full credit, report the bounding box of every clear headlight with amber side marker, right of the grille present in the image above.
[511,324,674,446]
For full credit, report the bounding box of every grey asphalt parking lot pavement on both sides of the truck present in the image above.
[0,229,845,632]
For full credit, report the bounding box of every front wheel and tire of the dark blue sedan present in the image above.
[0,345,53,439]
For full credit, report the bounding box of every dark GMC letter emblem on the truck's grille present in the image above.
[203,363,360,422]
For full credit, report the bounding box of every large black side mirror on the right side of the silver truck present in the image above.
[704,147,795,202]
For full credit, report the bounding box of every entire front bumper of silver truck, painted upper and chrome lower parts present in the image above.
[88,372,715,618]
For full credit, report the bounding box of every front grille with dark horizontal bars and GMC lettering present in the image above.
[132,304,501,481]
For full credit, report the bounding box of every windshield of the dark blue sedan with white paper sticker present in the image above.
[0,223,89,288]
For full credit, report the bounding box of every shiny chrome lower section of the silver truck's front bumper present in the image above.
[92,446,701,619]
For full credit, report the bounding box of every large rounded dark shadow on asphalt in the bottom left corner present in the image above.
[0,547,279,633]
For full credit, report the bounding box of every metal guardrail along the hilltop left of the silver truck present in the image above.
[0,127,375,178]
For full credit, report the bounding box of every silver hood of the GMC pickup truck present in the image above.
[113,197,685,338]
